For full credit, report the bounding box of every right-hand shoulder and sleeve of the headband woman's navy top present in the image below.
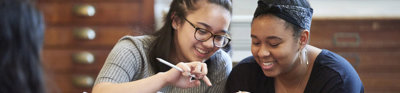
[309,49,364,93]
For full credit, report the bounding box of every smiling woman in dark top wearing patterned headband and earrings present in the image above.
[226,0,364,93]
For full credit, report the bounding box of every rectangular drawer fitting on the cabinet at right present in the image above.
[333,32,361,47]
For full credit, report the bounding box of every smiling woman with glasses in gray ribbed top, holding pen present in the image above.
[93,0,232,93]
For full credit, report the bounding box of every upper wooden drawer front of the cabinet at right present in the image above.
[310,30,400,49]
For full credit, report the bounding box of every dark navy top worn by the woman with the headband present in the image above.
[225,49,364,93]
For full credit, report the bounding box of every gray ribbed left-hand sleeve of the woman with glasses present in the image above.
[95,40,142,84]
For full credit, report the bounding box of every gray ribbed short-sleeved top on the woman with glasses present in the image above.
[95,35,232,93]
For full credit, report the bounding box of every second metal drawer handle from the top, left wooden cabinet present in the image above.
[74,27,96,40]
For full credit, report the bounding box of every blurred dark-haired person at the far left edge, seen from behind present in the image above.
[0,0,45,93]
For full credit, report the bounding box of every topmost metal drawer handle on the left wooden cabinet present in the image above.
[74,4,96,17]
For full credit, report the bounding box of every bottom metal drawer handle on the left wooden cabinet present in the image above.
[72,75,94,88]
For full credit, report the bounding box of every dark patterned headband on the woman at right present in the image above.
[253,1,313,31]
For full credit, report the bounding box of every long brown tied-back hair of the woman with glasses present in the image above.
[148,0,232,73]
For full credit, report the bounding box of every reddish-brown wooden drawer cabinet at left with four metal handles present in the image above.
[36,0,154,93]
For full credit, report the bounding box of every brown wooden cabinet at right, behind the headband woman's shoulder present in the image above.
[310,19,400,93]
